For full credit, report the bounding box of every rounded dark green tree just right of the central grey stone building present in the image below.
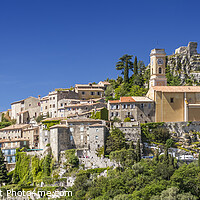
[106,128,126,153]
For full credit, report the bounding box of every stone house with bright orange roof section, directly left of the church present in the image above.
[108,96,155,123]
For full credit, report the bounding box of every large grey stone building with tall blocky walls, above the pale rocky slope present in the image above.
[40,119,107,160]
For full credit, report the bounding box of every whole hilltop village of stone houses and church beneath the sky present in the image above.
[0,42,200,198]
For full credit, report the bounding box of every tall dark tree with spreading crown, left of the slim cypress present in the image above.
[116,54,133,83]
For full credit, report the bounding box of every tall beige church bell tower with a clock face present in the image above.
[149,49,167,88]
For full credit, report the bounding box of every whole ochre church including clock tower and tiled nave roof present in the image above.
[146,43,200,122]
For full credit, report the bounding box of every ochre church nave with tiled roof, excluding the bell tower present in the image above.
[147,86,200,122]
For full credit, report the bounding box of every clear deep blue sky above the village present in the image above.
[0,0,200,111]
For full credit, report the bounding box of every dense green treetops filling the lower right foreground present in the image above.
[66,151,200,200]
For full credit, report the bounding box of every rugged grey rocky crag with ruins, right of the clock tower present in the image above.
[167,42,200,85]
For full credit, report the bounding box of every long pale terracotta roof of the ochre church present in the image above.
[152,86,200,92]
